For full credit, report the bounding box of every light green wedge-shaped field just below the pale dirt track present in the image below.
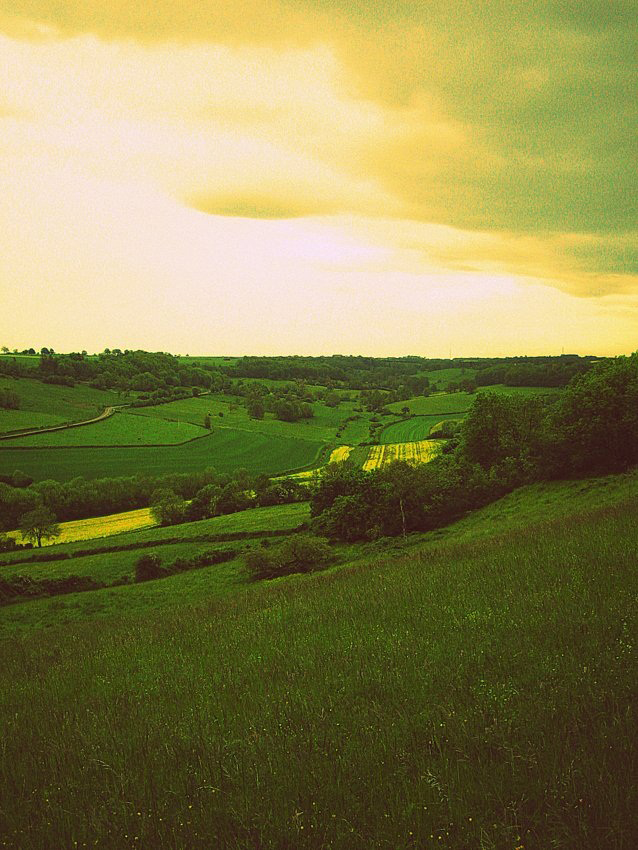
[2,412,208,448]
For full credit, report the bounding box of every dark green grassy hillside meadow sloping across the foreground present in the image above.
[0,477,638,850]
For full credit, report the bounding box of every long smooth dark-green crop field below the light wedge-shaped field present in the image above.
[0,428,323,481]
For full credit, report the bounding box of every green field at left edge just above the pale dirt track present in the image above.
[0,377,122,432]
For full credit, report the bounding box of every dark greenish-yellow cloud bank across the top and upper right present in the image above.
[0,0,638,238]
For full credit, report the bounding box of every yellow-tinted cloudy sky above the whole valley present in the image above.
[0,0,638,357]
